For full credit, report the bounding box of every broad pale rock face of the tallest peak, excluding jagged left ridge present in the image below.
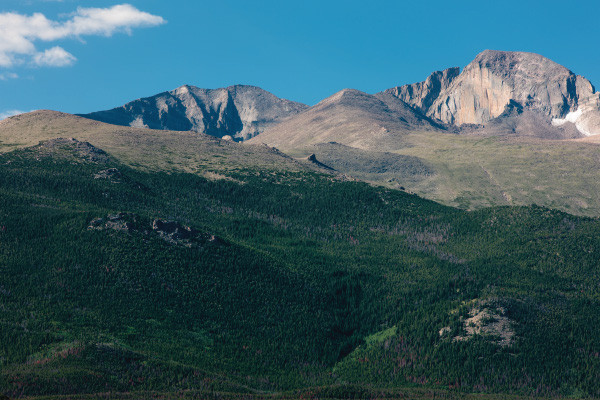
[427,50,600,135]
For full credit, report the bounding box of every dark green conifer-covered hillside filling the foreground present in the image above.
[0,140,600,398]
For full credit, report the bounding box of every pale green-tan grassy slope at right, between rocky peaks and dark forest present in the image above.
[282,132,600,216]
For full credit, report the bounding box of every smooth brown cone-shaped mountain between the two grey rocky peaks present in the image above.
[248,89,442,151]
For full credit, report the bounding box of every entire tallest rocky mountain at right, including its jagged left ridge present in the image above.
[385,50,600,138]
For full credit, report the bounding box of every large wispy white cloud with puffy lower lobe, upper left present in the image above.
[0,4,166,67]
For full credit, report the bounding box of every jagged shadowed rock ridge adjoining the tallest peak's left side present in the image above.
[384,67,460,114]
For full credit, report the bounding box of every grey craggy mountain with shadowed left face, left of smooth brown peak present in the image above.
[81,85,307,140]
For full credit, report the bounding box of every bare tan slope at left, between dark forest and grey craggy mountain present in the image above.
[0,110,324,172]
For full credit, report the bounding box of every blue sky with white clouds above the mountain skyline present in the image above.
[0,0,600,116]
